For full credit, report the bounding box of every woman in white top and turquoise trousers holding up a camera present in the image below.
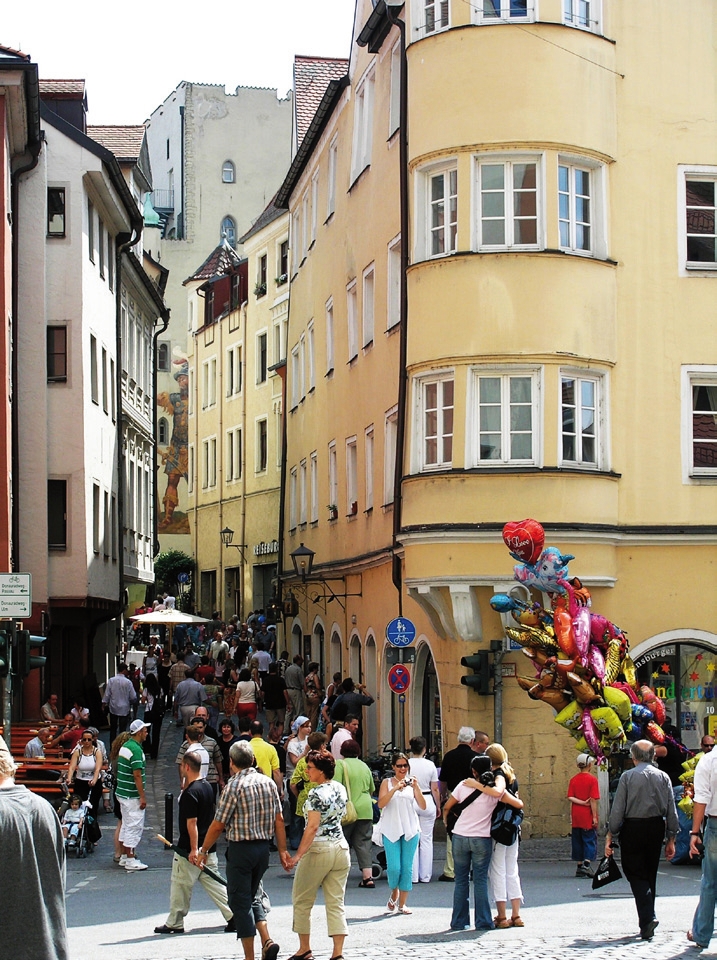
[378,753,426,913]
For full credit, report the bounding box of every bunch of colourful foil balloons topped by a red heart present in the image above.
[490,519,665,761]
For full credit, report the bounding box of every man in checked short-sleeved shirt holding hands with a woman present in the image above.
[192,741,289,960]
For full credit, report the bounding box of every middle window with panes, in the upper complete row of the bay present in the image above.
[478,159,538,249]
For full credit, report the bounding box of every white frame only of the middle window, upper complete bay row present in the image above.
[473,153,544,252]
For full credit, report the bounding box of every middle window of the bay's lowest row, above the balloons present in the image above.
[472,370,539,466]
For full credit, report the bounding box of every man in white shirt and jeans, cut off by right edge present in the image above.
[687,749,717,947]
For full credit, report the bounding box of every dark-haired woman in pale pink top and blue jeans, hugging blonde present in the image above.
[443,755,520,930]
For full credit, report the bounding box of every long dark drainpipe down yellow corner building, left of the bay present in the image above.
[386,7,409,616]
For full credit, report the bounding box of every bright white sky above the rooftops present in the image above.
[0,0,355,125]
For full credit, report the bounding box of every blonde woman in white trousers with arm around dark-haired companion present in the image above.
[485,743,525,930]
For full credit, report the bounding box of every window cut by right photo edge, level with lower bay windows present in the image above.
[682,366,717,479]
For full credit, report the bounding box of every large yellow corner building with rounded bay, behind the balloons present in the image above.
[277,0,717,834]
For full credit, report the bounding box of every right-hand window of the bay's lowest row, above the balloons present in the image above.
[560,372,602,468]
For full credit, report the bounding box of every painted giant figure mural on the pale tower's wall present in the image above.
[157,357,189,533]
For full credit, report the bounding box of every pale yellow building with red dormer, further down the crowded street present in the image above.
[187,205,289,620]
